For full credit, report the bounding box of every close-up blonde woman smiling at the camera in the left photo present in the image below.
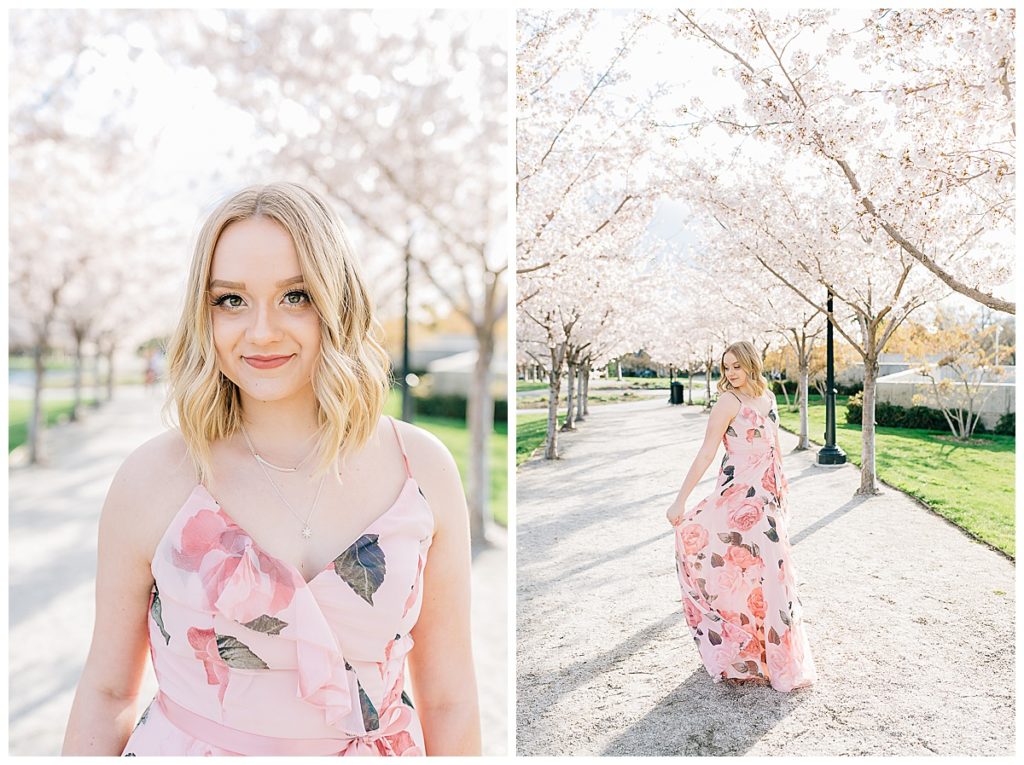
[63,183,480,756]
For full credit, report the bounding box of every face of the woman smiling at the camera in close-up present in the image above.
[210,217,321,401]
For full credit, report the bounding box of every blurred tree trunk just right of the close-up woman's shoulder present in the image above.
[466,332,495,546]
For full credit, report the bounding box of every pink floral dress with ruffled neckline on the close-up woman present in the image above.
[123,420,433,756]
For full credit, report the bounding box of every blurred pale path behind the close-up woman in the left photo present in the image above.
[8,387,508,755]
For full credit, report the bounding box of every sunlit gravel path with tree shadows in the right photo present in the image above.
[516,400,1015,755]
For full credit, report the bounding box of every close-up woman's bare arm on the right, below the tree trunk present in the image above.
[402,426,481,756]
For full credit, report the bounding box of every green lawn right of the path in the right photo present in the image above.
[779,396,1016,557]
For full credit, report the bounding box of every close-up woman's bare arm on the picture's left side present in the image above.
[62,436,193,755]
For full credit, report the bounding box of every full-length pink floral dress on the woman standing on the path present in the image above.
[676,391,817,691]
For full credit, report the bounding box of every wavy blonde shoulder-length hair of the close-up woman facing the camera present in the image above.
[164,182,391,483]
